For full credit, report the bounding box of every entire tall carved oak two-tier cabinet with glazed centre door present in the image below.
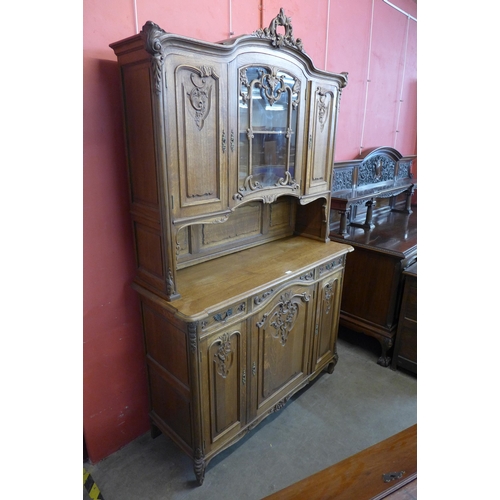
[111,10,352,484]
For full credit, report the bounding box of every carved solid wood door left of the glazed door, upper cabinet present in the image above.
[165,55,228,219]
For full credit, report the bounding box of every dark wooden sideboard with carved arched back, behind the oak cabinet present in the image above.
[330,147,417,367]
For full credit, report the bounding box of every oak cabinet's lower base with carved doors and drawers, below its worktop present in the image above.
[134,242,349,485]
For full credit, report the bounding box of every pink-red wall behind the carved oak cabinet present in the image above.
[83,0,417,463]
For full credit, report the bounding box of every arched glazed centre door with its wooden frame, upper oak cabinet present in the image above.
[230,54,307,203]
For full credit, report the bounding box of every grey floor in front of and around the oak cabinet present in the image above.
[83,334,417,500]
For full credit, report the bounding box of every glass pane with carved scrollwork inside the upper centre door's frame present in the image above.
[238,66,300,196]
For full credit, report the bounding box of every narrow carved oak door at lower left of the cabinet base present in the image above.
[201,322,248,454]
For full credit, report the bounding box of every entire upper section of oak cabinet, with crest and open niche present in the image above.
[111,10,347,300]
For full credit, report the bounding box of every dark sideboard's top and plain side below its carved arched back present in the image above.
[330,206,417,366]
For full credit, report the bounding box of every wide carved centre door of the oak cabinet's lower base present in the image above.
[250,285,314,418]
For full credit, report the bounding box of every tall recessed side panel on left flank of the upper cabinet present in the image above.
[122,62,158,207]
